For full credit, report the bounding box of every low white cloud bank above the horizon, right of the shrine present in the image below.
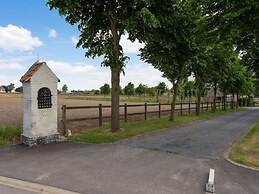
[46,60,171,90]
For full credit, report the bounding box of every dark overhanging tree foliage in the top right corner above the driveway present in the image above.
[202,0,259,75]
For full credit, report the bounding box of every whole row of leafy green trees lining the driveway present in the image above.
[48,0,259,132]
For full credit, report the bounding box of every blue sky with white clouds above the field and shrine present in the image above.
[0,0,171,90]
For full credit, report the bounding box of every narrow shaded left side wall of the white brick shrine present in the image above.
[23,82,31,136]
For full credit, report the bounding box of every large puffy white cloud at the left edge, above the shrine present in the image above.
[0,24,42,52]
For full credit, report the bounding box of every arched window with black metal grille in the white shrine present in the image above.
[38,87,52,109]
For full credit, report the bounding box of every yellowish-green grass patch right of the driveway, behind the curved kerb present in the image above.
[230,121,259,168]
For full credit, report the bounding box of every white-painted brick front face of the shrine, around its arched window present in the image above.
[29,65,58,137]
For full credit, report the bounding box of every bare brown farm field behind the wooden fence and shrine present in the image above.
[0,93,195,132]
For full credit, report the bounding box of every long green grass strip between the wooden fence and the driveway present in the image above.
[68,109,240,143]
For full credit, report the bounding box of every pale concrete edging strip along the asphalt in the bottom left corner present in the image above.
[0,176,80,194]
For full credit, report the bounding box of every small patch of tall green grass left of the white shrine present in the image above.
[0,125,22,146]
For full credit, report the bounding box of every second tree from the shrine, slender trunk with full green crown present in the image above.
[141,0,195,120]
